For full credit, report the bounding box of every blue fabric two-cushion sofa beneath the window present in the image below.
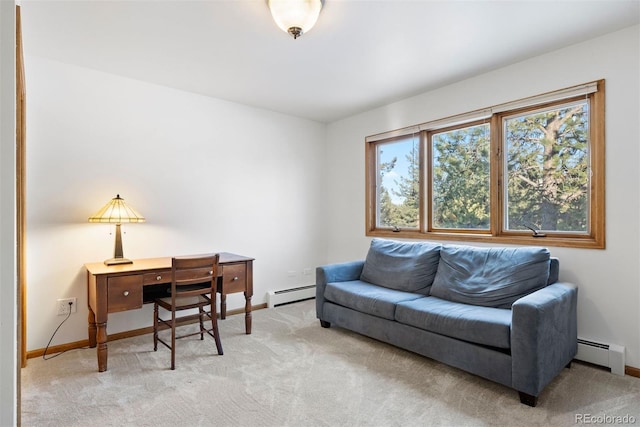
[316,239,578,406]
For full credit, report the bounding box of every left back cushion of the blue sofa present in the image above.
[360,239,442,295]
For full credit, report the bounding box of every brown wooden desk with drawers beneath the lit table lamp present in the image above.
[84,252,253,372]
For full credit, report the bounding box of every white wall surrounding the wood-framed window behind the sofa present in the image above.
[327,26,640,367]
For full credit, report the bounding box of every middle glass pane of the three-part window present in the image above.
[431,124,490,230]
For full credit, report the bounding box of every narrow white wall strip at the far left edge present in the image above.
[0,1,19,426]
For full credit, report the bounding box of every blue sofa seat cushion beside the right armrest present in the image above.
[396,297,511,349]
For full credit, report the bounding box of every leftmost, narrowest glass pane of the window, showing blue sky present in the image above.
[376,136,420,229]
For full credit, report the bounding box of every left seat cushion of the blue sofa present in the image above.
[324,280,424,320]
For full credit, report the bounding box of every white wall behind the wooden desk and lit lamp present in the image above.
[25,56,326,350]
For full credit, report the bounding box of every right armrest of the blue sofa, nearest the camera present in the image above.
[511,282,578,396]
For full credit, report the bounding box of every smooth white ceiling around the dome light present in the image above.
[20,0,640,122]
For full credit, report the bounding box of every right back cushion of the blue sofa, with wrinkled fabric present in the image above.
[430,245,550,308]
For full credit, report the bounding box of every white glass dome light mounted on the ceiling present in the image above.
[267,0,324,39]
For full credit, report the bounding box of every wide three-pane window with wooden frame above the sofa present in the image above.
[366,80,605,248]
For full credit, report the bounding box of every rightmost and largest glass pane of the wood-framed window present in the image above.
[504,100,589,233]
